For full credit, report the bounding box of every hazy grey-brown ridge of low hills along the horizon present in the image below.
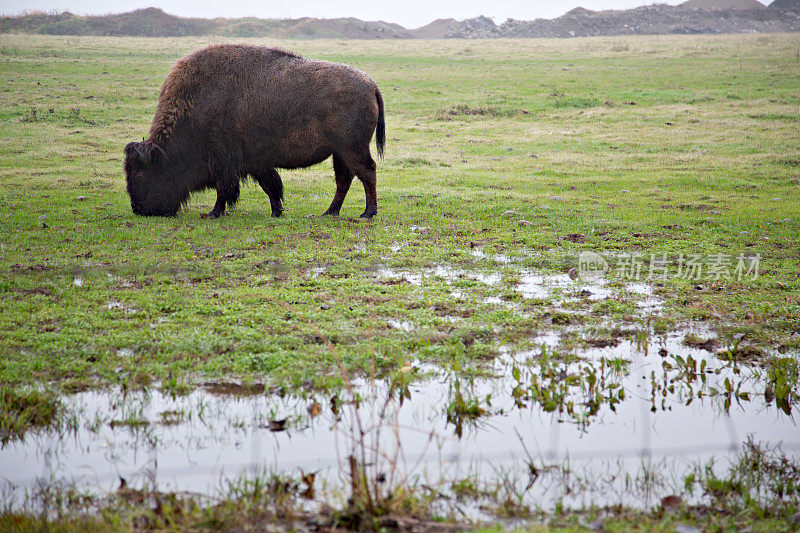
[0,5,800,38]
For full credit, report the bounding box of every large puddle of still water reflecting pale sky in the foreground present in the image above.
[0,323,800,507]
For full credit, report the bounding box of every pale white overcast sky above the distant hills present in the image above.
[0,0,708,28]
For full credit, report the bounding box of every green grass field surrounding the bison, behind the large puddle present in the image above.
[0,35,800,530]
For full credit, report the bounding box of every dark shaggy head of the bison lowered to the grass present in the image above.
[125,140,188,216]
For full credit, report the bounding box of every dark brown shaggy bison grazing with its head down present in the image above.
[125,45,386,218]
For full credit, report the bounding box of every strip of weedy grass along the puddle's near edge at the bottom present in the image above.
[0,439,800,532]
